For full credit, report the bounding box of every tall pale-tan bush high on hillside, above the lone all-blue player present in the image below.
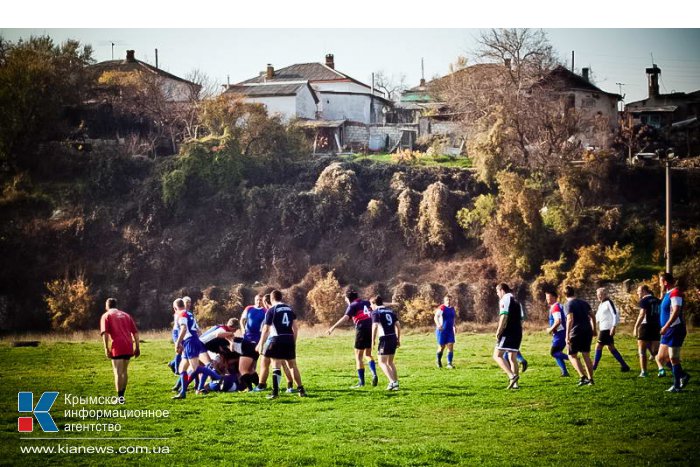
[418,182,455,254]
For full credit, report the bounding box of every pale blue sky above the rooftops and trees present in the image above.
[0,28,700,102]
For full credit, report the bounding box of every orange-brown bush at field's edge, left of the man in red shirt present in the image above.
[44,274,95,331]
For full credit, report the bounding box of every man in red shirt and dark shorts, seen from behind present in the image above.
[100,298,141,398]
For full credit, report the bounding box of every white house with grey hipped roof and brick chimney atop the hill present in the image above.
[224,54,391,124]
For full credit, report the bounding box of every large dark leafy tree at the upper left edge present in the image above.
[0,36,93,169]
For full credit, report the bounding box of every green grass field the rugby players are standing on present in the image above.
[0,333,700,466]
